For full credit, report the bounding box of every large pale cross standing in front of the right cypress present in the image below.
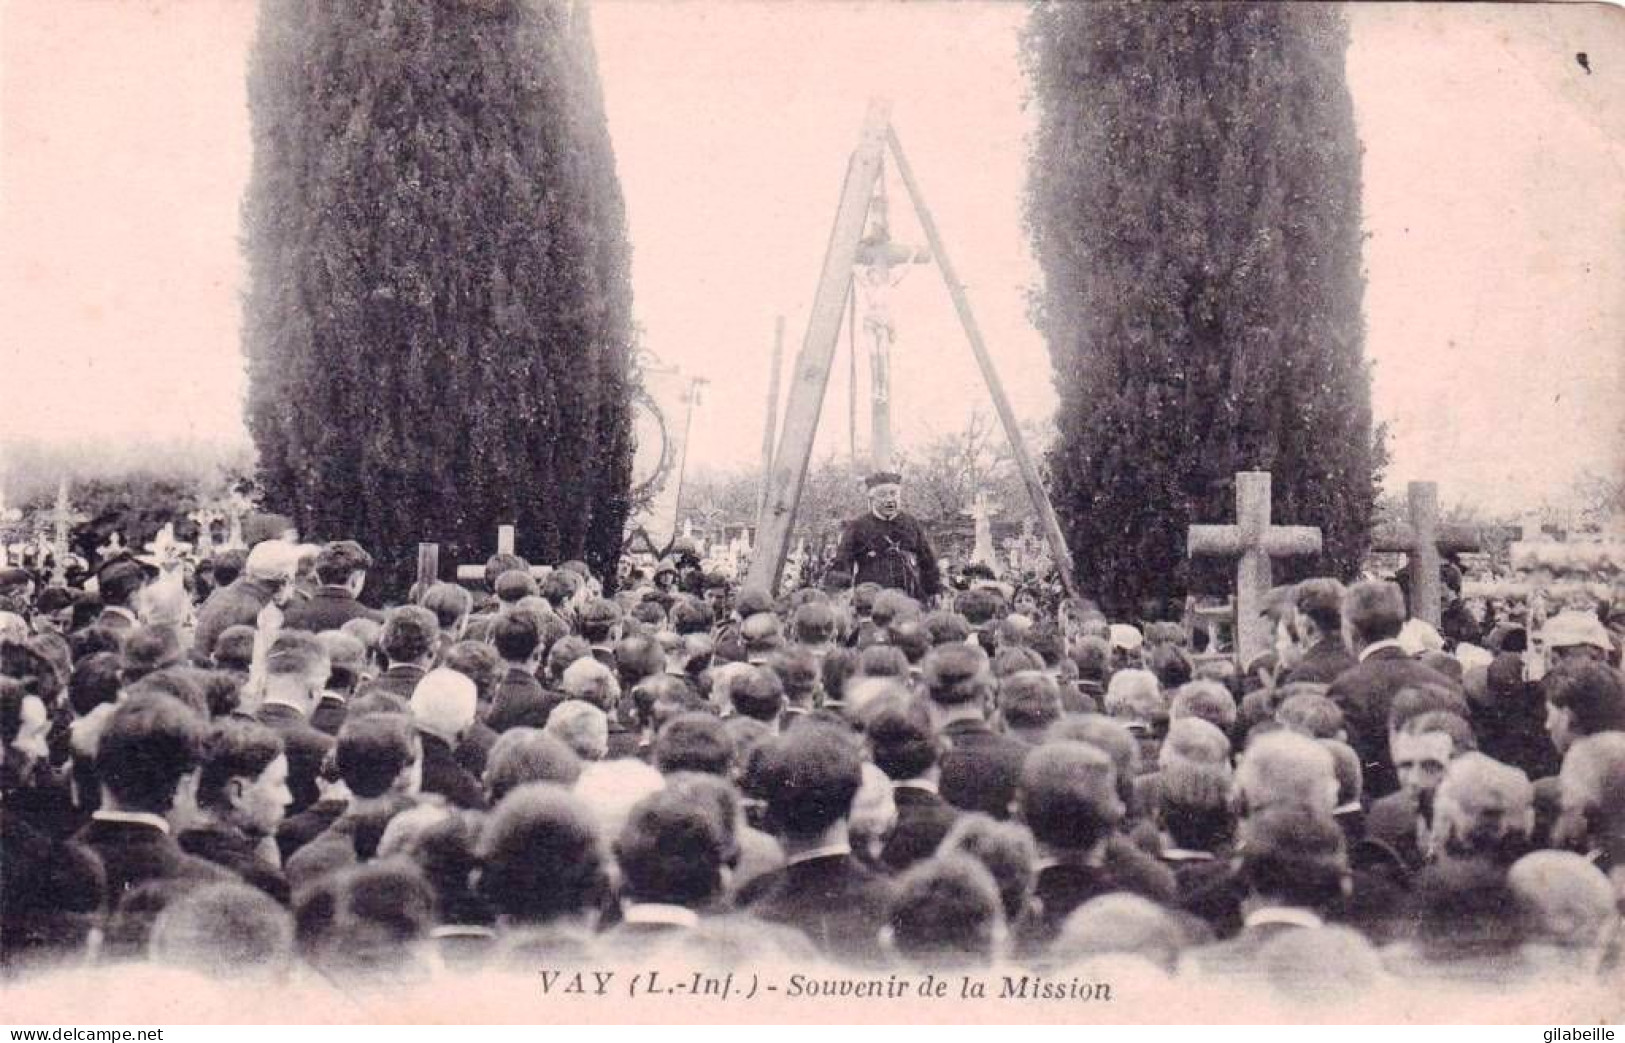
[1186,471,1321,664]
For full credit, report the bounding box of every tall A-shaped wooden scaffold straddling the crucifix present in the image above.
[746,99,1079,598]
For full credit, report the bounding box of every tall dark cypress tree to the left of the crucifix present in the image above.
[244,0,632,590]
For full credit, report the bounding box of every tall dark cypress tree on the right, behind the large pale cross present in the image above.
[1025,3,1385,611]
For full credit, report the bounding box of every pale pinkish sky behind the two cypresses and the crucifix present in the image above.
[0,0,1625,510]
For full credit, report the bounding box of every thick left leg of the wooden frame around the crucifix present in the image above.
[744,99,891,591]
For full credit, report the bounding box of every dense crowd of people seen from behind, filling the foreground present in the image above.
[0,526,1625,993]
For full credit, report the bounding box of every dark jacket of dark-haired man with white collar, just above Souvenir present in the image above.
[738,855,892,967]
